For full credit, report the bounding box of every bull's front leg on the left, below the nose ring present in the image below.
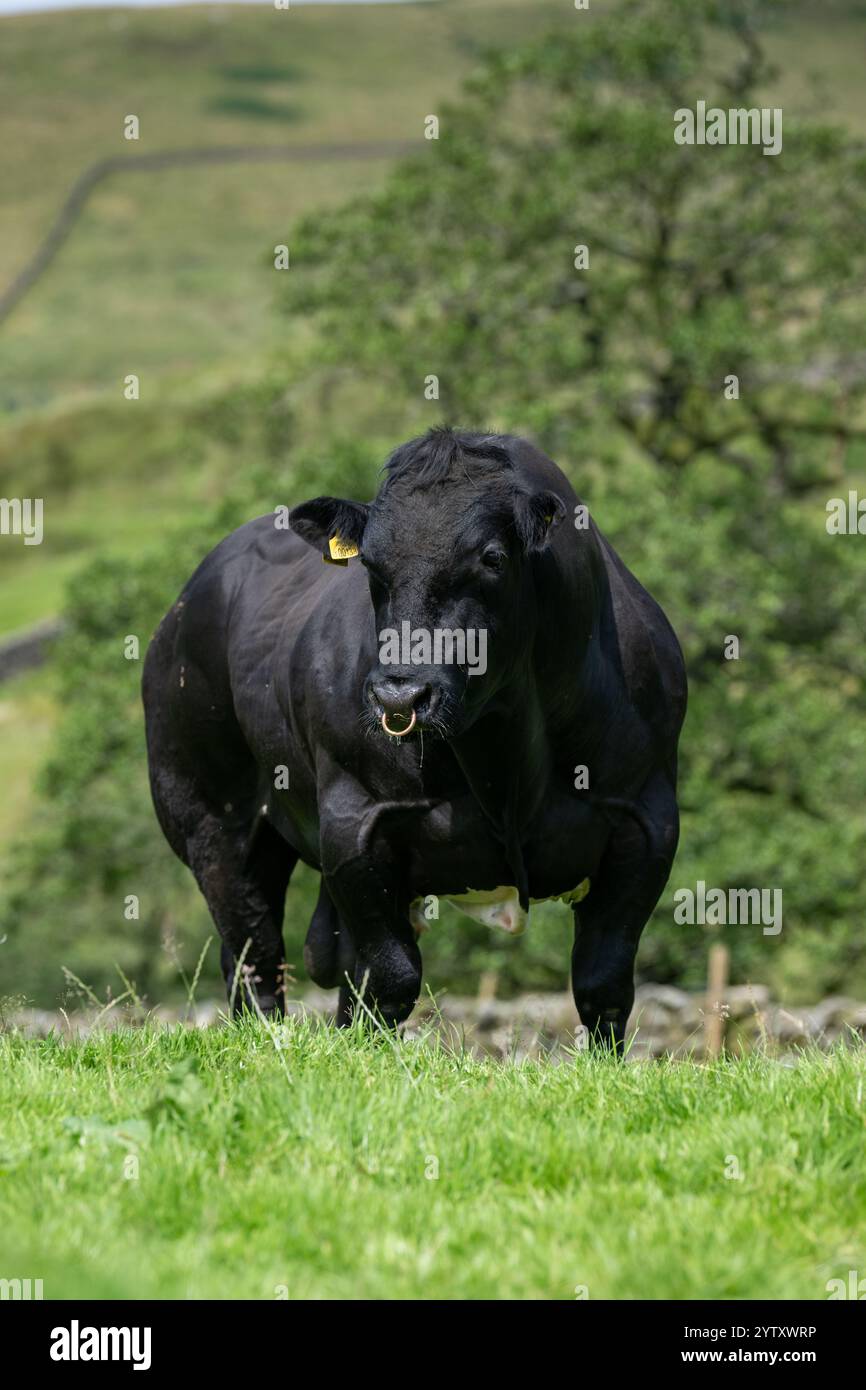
[322,803,421,1027]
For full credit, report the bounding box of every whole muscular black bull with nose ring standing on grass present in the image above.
[143,430,685,1045]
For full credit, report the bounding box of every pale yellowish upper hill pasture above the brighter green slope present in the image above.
[0,0,560,410]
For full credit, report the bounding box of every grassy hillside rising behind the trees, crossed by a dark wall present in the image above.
[0,0,866,634]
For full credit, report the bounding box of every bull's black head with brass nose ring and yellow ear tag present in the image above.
[291,430,566,737]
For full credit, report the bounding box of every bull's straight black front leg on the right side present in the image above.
[571,777,678,1052]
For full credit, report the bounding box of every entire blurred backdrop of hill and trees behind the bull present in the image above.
[0,0,866,1006]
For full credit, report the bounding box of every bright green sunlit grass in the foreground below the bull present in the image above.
[0,1020,866,1300]
